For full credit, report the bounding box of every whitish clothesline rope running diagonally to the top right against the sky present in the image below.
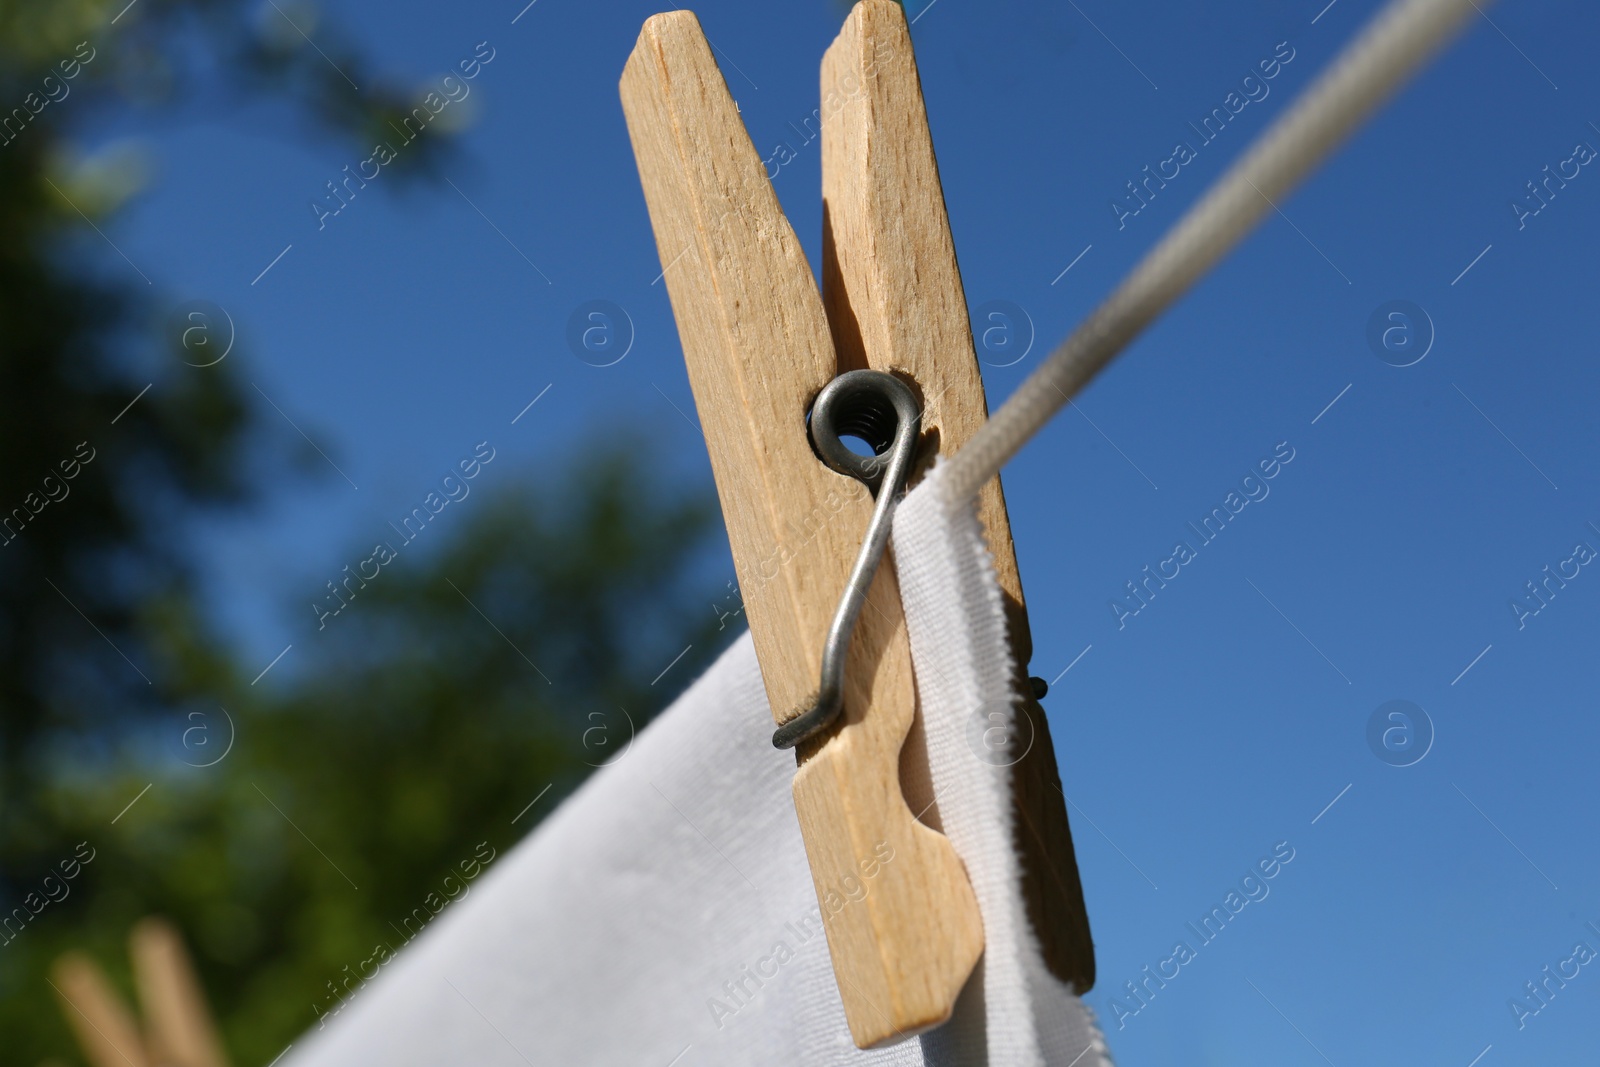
[944,0,1490,504]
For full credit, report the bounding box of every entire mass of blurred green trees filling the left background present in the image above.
[0,0,733,1067]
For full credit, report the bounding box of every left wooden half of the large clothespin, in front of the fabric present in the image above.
[621,11,982,1048]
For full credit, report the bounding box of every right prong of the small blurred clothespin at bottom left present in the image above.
[128,918,227,1067]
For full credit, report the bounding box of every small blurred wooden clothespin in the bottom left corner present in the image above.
[53,918,227,1067]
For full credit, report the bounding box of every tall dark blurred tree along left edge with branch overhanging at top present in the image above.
[0,0,467,888]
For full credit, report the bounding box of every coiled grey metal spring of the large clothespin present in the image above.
[773,370,922,749]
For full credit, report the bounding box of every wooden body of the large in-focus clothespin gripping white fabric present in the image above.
[621,0,1094,1048]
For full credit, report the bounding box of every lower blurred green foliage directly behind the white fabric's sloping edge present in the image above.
[0,451,718,1064]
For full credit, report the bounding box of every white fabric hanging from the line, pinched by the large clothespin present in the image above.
[283,470,1110,1067]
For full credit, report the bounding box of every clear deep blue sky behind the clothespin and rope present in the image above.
[85,0,1600,1067]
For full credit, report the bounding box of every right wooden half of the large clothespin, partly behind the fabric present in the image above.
[819,0,1094,992]
